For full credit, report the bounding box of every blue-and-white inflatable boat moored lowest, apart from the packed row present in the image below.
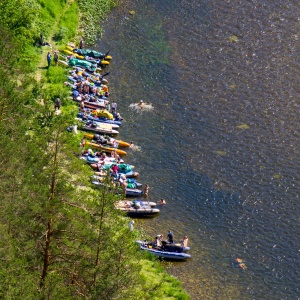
[139,243,192,260]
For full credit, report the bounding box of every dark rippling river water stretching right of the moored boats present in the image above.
[99,0,300,299]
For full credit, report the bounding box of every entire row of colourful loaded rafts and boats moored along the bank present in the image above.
[65,42,191,260]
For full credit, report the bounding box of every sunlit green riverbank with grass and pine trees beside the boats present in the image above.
[0,0,189,299]
